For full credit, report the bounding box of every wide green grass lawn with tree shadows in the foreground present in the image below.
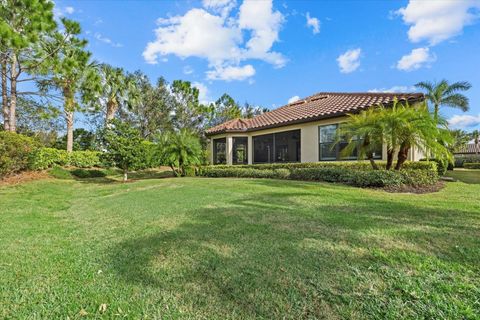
[0,174,480,319]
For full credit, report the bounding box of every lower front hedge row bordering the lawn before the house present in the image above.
[197,162,438,187]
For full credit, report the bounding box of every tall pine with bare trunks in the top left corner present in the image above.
[0,0,56,131]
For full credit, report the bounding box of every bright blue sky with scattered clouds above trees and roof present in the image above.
[55,0,480,130]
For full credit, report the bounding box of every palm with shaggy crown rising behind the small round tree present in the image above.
[90,64,138,123]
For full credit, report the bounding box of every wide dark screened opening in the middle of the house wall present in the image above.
[253,130,300,163]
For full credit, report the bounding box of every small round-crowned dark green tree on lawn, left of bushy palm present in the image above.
[100,119,143,182]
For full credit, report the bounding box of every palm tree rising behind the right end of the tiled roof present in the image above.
[415,80,472,120]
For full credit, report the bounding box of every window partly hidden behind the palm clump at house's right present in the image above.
[319,124,382,161]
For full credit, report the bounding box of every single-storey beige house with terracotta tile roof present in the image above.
[206,92,424,164]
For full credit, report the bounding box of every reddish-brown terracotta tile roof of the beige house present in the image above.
[206,92,424,135]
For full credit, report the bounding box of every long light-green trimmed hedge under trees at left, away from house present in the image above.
[30,148,102,170]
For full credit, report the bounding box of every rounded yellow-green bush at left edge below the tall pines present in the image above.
[0,131,38,178]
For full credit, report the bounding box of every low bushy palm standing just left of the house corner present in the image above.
[159,129,203,176]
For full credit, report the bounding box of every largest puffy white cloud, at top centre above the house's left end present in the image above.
[143,0,286,81]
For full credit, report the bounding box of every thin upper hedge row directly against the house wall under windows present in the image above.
[208,161,437,170]
